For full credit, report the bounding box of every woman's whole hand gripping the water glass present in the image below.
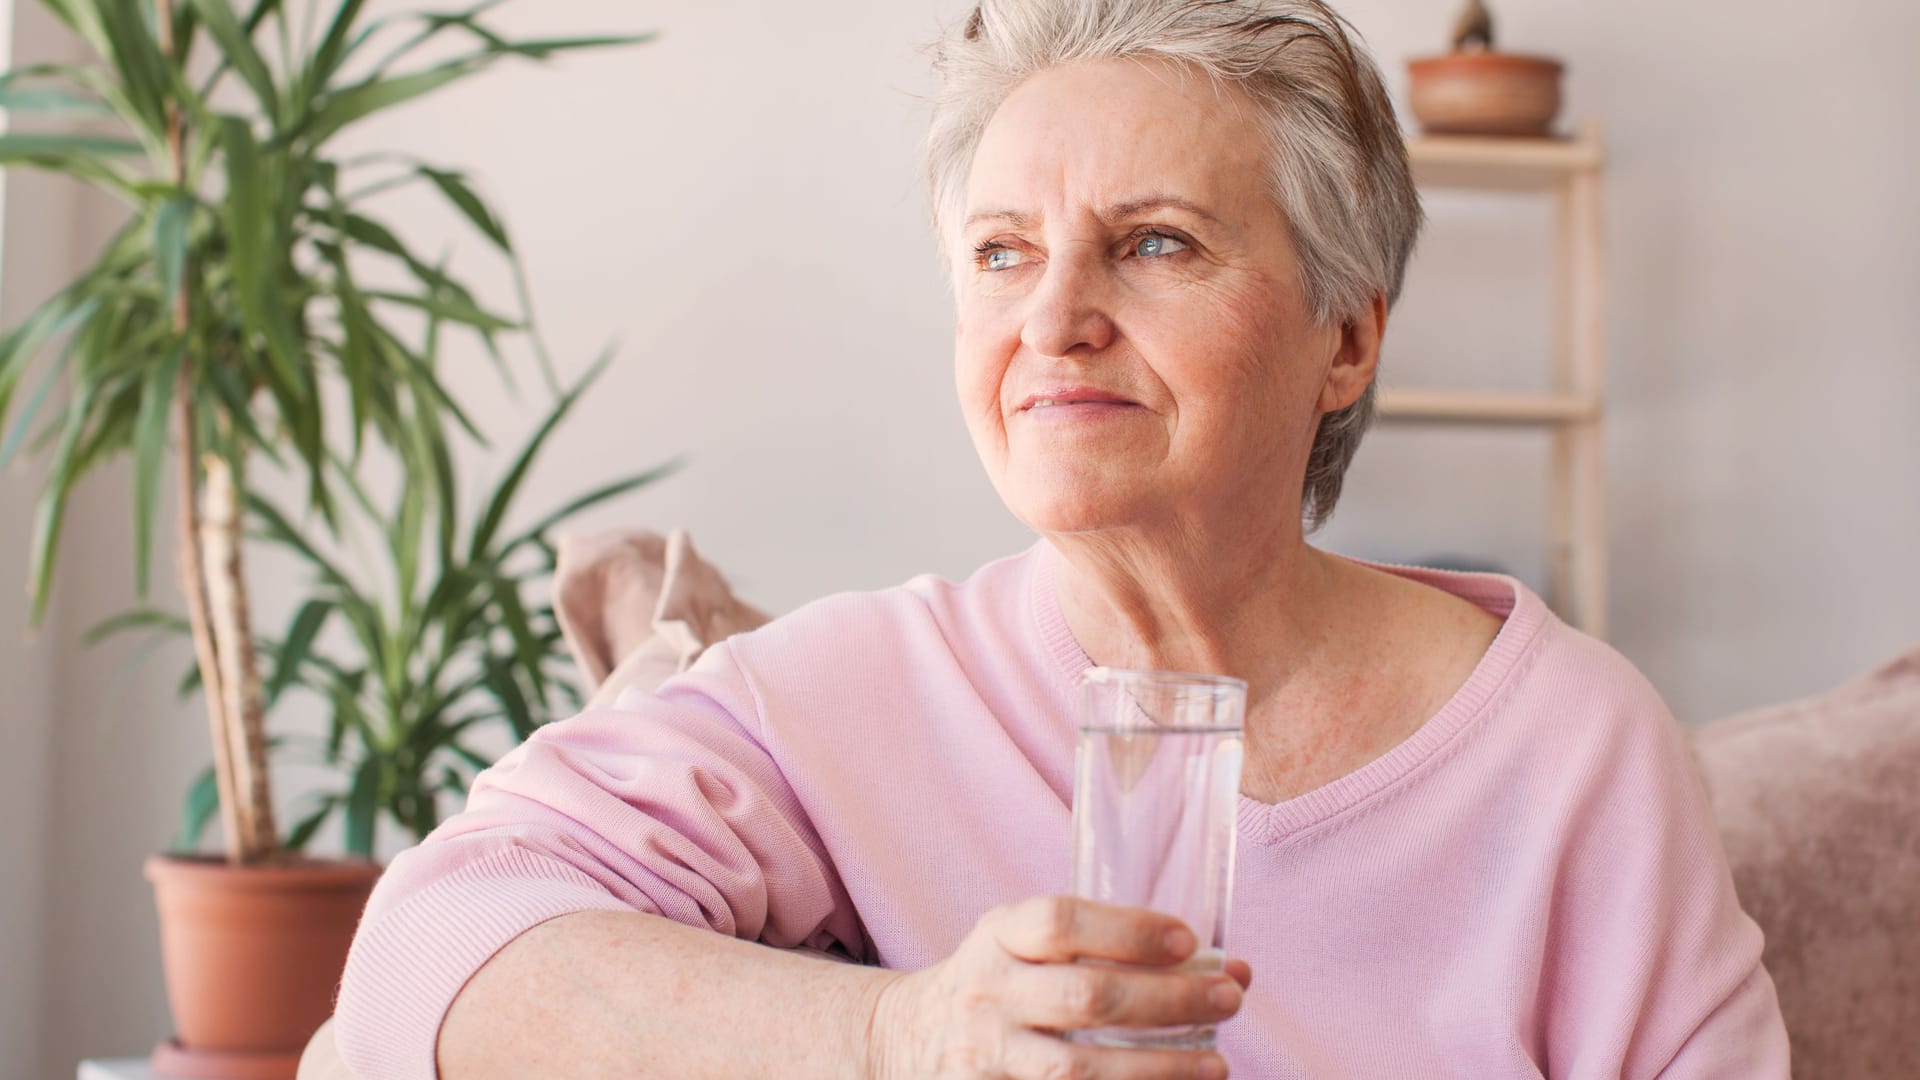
[868,896,1252,1080]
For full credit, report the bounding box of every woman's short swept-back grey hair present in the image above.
[927,0,1421,528]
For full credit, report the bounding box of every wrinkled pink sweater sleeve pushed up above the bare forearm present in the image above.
[336,646,862,1080]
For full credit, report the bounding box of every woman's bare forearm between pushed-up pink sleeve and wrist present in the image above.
[438,911,899,1080]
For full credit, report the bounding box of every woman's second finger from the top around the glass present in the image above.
[1000,963,1242,1032]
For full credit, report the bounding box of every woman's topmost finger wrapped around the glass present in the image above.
[989,896,1196,967]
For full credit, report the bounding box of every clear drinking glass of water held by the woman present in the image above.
[1069,667,1246,1049]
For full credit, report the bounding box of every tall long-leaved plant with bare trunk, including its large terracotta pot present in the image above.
[0,0,643,1076]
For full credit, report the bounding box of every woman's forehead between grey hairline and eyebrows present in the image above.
[964,60,1265,219]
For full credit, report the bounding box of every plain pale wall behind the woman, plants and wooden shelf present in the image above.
[0,0,1920,1076]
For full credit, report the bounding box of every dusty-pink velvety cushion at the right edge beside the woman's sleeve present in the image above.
[1693,650,1920,1080]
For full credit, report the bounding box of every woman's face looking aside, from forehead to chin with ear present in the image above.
[948,60,1371,534]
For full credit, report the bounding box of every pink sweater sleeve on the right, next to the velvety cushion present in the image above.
[1544,638,1788,1080]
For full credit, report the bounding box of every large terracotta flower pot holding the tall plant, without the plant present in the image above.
[146,855,380,1080]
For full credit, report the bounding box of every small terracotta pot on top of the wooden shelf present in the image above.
[1407,52,1563,136]
